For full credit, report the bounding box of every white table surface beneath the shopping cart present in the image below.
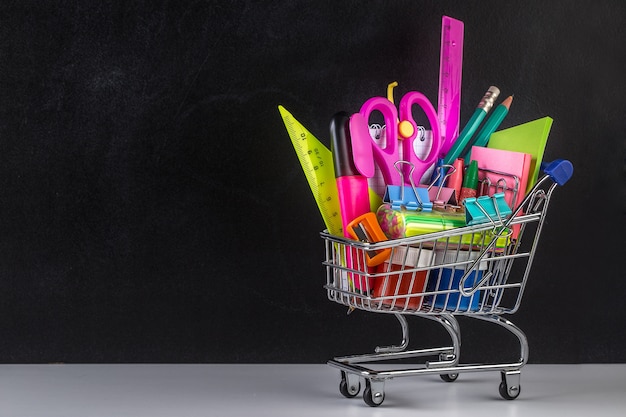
[0,364,626,417]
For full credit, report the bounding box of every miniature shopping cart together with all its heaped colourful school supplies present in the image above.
[279,16,573,406]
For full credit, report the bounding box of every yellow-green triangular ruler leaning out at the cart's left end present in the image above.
[278,106,343,236]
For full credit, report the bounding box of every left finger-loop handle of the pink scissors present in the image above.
[359,97,401,185]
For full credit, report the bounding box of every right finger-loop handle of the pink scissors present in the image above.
[399,91,443,184]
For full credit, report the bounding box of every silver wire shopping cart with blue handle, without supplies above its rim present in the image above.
[321,160,573,406]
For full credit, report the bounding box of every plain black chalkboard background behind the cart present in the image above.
[0,0,626,363]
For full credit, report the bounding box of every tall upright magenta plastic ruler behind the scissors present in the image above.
[437,16,463,156]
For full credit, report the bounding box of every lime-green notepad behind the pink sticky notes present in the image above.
[487,117,552,192]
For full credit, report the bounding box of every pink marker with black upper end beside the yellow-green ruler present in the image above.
[330,112,371,237]
